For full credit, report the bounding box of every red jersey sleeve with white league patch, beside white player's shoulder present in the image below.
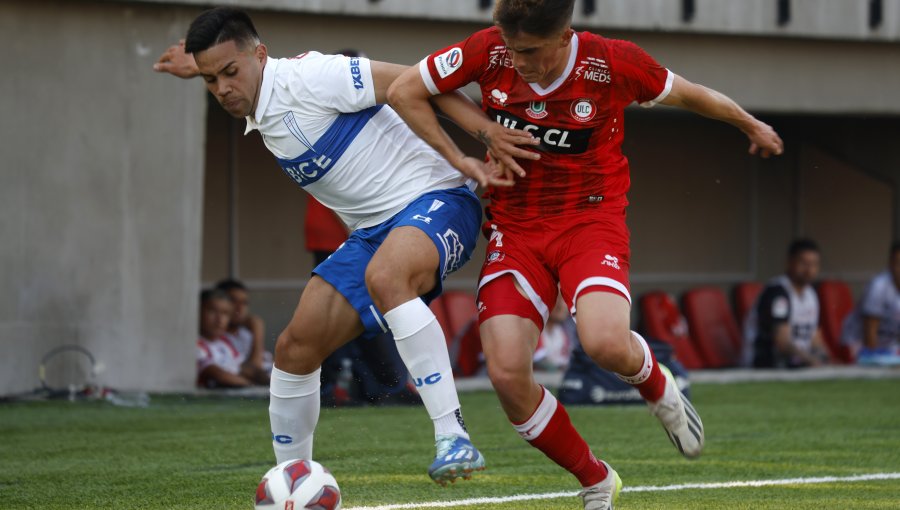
[419,32,489,95]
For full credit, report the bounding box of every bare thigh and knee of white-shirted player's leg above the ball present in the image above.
[275,275,363,373]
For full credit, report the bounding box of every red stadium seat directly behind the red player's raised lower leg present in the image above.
[640,291,703,370]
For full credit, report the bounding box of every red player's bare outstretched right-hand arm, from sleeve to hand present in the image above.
[662,75,784,158]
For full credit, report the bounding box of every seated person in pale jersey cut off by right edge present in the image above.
[842,242,900,364]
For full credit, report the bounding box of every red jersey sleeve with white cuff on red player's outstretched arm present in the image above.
[612,40,675,108]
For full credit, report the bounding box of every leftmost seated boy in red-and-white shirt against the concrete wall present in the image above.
[197,289,265,388]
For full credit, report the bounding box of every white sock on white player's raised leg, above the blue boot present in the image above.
[384,298,469,439]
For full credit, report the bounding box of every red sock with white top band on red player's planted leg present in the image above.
[513,388,608,487]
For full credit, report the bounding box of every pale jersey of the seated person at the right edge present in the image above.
[842,271,900,349]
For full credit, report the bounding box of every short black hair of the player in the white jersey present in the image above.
[184,7,259,53]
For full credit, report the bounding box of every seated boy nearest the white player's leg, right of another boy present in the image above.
[216,280,272,380]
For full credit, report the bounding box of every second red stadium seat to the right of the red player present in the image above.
[683,287,741,368]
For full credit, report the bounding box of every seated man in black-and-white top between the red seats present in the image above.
[744,239,828,368]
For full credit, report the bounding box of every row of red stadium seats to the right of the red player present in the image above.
[639,280,853,370]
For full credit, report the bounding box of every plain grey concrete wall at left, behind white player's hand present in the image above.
[0,1,205,394]
